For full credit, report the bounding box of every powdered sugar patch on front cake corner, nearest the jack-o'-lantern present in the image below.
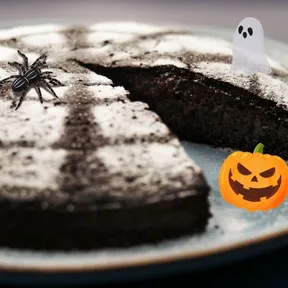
[95,143,198,198]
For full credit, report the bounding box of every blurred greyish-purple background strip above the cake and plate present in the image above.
[0,0,288,42]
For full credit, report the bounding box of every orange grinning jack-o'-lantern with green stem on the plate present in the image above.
[218,143,288,212]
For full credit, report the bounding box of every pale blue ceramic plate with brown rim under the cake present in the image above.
[0,26,288,283]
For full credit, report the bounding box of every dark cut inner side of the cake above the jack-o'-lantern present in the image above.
[77,61,288,159]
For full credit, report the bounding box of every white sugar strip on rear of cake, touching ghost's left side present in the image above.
[154,35,232,55]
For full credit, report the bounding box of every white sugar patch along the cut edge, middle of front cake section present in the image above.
[94,102,169,139]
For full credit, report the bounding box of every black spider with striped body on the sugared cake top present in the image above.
[0,50,63,110]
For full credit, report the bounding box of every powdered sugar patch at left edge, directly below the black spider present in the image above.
[0,98,68,148]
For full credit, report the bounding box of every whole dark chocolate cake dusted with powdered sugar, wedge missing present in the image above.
[0,23,288,250]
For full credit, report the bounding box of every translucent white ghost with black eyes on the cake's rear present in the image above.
[231,17,271,75]
